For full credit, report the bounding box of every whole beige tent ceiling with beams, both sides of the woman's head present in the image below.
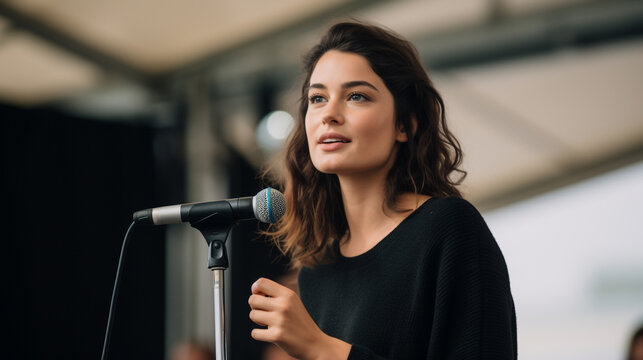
[0,0,643,206]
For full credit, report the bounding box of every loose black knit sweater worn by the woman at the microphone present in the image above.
[299,197,517,360]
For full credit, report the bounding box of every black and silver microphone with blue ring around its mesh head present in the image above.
[133,188,286,225]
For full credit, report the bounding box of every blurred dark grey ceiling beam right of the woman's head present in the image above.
[412,0,643,71]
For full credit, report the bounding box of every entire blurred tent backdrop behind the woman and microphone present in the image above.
[0,0,643,360]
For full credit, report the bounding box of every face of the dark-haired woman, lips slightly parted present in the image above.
[305,50,406,175]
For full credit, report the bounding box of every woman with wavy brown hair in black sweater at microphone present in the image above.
[248,22,516,359]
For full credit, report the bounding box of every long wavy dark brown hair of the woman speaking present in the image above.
[267,21,466,267]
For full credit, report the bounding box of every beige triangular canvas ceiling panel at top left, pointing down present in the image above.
[0,0,358,73]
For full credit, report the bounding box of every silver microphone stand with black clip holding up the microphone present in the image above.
[190,208,237,360]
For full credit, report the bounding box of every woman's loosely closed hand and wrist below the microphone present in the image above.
[248,278,351,360]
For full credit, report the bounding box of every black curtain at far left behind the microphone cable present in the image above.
[0,105,174,359]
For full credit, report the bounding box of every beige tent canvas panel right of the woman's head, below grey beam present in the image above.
[436,40,643,205]
